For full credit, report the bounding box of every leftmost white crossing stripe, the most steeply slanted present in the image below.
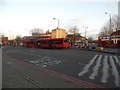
[78,55,98,76]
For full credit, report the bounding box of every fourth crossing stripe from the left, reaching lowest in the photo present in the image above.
[110,56,120,87]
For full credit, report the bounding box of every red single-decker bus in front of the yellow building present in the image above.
[38,38,70,48]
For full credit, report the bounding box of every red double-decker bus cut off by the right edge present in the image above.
[98,35,120,47]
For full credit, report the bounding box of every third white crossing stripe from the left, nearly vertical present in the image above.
[101,55,109,83]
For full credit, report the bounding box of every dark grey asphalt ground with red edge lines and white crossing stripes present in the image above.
[2,46,120,88]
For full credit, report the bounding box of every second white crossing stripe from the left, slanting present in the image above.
[89,55,102,79]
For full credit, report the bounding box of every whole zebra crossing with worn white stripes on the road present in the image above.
[78,54,120,87]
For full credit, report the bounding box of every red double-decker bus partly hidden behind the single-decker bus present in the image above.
[22,36,51,47]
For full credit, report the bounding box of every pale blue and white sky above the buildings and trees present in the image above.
[0,0,119,38]
